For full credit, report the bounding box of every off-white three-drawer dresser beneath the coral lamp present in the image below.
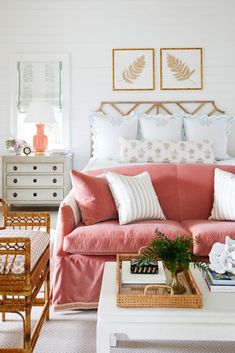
[2,153,72,206]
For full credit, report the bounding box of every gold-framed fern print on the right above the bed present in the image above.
[160,48,203,90]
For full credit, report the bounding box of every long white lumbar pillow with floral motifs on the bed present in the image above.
[119,138,215,164]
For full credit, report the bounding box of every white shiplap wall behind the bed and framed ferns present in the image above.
[0,0,235,194]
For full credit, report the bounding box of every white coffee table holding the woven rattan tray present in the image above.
[96,262,235,353]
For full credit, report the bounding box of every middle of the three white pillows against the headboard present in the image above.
[139,114,183,140]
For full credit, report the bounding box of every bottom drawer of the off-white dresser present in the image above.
[7,188,64,201]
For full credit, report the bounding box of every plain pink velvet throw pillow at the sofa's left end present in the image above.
[71,170,117,225]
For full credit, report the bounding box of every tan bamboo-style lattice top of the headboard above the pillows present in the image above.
[97,100,225,116]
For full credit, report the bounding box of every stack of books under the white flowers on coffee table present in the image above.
[205,270,235,293]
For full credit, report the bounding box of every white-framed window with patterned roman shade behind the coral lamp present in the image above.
[11,53,69,149]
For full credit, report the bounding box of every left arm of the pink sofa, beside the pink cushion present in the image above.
[54,190,81,255]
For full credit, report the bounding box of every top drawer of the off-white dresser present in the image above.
[7,163,64,174]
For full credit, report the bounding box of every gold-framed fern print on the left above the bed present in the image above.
[112,48,155,91]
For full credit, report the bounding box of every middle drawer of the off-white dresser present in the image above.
[7,174,64,187]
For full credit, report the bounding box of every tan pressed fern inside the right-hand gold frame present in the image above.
[167,53,195,81]
